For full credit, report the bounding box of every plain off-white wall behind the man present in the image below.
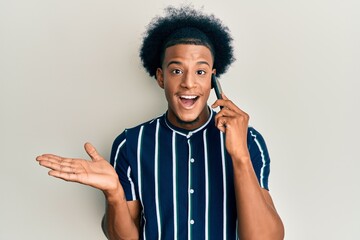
[0,0,360,240]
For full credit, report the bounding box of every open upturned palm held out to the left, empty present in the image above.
[36,143,119,192]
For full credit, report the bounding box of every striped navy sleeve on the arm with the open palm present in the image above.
[110,131,139,201]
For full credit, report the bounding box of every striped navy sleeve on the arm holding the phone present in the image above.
[247,127,270,190]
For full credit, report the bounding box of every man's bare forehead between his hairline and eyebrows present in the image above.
[163,44,213,66]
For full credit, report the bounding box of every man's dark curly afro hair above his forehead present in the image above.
[140,6,235,77]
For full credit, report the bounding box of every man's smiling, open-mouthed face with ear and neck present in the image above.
[156,44,215,130]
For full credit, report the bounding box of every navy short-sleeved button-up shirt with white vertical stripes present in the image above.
[110,111,270,240]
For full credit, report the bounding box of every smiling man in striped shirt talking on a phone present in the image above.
[37,7,284,240]
